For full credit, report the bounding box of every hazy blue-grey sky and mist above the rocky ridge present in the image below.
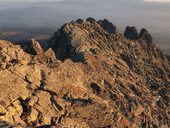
[0,0,170,43]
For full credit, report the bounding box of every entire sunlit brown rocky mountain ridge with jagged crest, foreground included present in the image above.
[0,18,170,128]
